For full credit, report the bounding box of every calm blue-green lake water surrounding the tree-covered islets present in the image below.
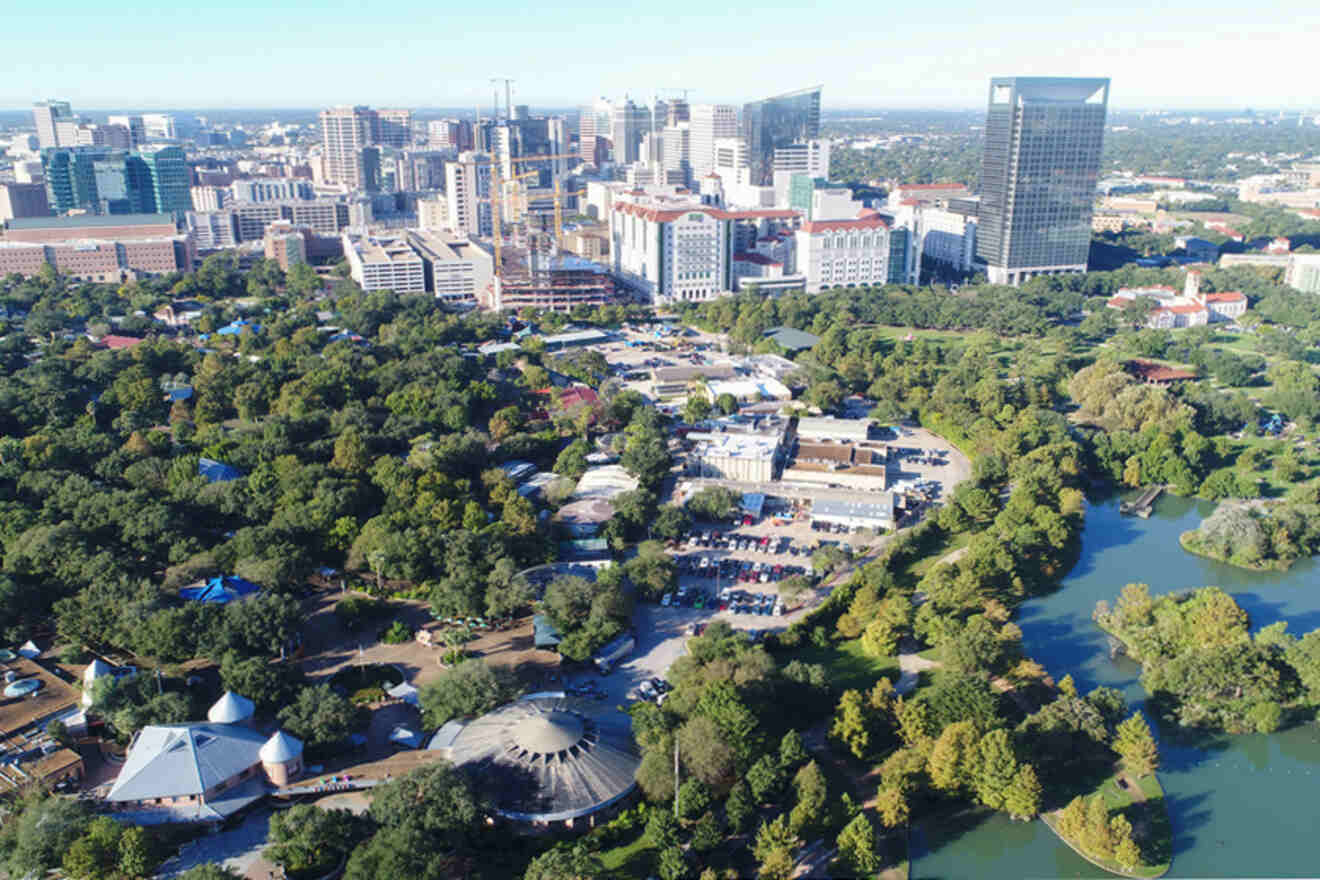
[912,496,1320,880]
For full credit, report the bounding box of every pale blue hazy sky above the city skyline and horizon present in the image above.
[0,0,1320,110]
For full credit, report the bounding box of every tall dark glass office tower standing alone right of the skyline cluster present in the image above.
[977,77,1109,285]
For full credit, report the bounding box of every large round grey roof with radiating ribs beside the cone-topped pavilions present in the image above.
[430,693,640,822]
